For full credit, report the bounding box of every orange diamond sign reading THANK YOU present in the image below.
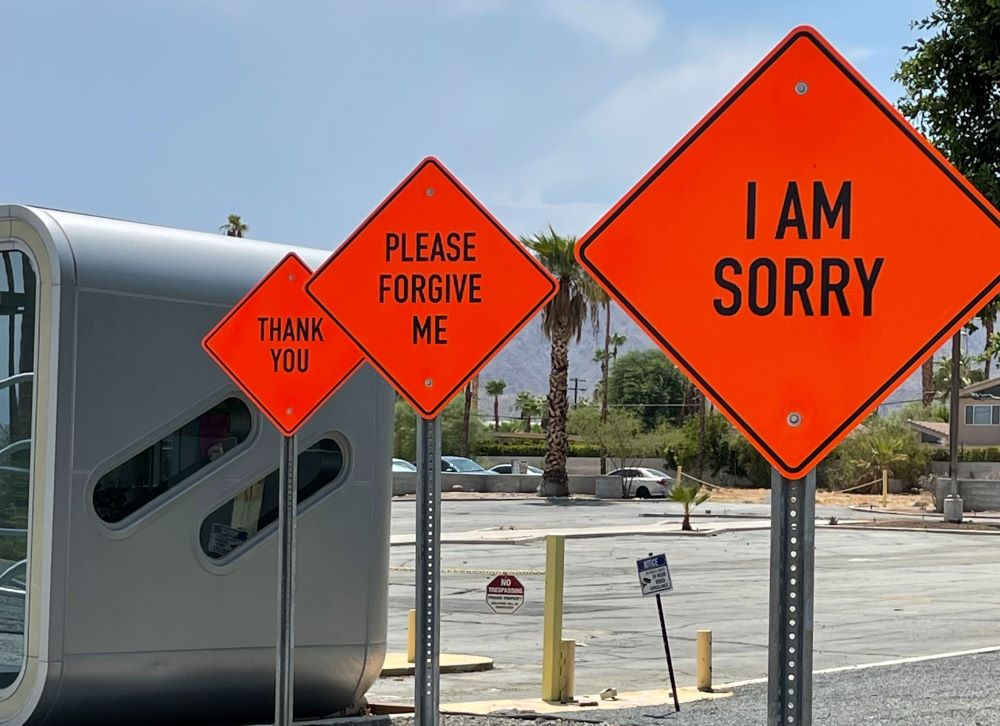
[202,253,362,436]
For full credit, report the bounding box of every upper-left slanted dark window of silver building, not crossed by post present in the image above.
[94,398,252,523]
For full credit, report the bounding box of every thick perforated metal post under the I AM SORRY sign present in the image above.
[767,470,816,726]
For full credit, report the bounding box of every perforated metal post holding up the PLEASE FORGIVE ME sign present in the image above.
[413,417,441,726]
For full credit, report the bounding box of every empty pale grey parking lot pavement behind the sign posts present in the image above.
[369,498,1000,703]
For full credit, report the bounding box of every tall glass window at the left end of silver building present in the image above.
[0,249,38,688]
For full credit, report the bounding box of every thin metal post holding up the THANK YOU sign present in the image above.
[274,435,298,726]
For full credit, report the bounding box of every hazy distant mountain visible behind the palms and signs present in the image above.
[479,304,1000,420]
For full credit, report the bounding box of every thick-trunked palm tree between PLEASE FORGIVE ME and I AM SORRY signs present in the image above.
[521,227,598,497]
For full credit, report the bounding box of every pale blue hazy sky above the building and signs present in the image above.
[0,0,933,249]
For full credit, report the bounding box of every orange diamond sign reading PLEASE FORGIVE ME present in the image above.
[306,158,557,419]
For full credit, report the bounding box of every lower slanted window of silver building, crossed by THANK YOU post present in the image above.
[201,439,345,559]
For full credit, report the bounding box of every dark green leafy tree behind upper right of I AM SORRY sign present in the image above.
[893,0,1000,404]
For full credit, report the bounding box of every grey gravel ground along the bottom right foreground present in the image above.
[393,653,1000,726]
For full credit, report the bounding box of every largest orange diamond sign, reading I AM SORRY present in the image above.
[577,27,1000,478]
